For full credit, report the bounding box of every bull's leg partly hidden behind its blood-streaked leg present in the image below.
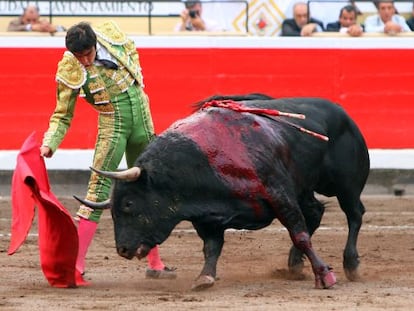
[288,196,325,277]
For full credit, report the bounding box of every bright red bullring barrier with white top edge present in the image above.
[0,37,414,150]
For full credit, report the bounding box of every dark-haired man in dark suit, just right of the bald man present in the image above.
[326,4,364,37]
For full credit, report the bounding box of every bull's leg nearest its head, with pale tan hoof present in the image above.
[191,225,224,291]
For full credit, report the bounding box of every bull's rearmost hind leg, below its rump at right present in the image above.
[338,196,365,281]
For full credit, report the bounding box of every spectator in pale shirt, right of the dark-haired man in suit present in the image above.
[364,0,411,35]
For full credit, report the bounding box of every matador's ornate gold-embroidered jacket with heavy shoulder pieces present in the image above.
[43,21,143,152]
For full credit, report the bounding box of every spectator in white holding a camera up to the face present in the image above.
[175,0,223,31]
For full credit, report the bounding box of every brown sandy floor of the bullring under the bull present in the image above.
[0,196,414,311]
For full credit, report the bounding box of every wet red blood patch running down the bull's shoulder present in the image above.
[170,108,278,215]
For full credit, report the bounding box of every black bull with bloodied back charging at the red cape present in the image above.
[77,94,369,290]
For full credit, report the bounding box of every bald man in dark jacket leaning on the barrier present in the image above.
[280,2,324,37]
